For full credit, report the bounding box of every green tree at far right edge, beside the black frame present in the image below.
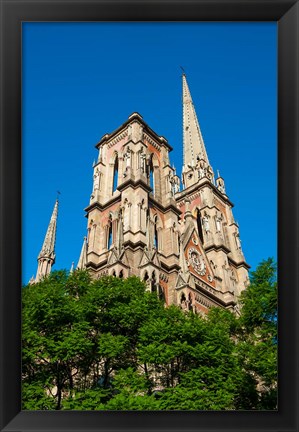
[238,259,278,410]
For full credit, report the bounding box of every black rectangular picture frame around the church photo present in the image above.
[0,0,299,432]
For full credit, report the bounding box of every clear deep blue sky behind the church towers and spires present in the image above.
[22,23,277,283]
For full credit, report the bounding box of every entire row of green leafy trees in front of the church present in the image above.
[22,260,277,410]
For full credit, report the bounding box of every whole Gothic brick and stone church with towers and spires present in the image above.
[35,74,249,313]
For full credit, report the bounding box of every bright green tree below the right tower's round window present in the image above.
[140,307,242,410]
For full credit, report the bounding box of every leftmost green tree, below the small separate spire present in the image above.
[22,271,92,410]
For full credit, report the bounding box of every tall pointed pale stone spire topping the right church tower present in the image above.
[183,73,210,169]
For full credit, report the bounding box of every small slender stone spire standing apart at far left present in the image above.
[35,199,58,282]
